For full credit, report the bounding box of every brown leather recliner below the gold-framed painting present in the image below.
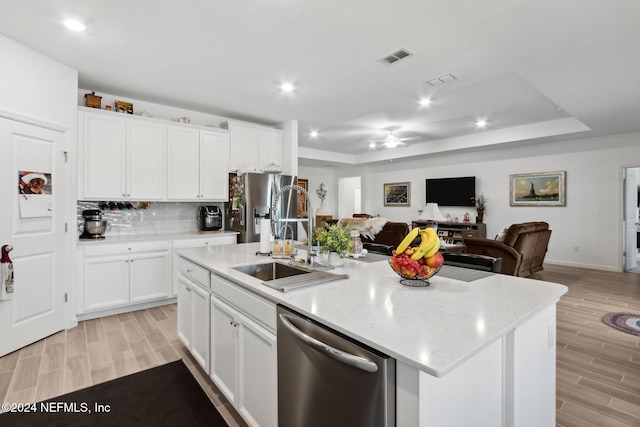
[464,221,551,277]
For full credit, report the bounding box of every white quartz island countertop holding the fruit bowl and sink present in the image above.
[177,243,567,377]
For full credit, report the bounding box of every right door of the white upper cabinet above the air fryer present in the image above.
[200,131,229,202]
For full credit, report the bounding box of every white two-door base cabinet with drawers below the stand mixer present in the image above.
[80,241,171,313]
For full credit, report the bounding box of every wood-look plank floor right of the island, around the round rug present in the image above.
[533,265,640,427]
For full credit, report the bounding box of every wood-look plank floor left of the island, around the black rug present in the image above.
[0,304,246,427]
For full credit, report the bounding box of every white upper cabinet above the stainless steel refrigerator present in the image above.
[225,120,286,172]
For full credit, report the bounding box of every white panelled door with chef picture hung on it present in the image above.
[0,118,70,356]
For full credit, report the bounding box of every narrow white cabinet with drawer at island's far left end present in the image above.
[178,258,210,372]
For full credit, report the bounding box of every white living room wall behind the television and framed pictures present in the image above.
[300,133,640,271]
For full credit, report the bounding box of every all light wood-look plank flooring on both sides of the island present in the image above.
[0,265,640,427]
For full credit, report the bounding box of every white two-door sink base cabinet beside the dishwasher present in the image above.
[210,274,278,426]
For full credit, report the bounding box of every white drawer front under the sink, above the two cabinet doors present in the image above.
[211,274,276,332]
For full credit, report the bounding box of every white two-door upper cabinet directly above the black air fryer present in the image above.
[167,126,229,201]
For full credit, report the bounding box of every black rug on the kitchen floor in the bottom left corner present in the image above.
[0,360,228,427]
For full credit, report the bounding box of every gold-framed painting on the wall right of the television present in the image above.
[509,171,566,206]
